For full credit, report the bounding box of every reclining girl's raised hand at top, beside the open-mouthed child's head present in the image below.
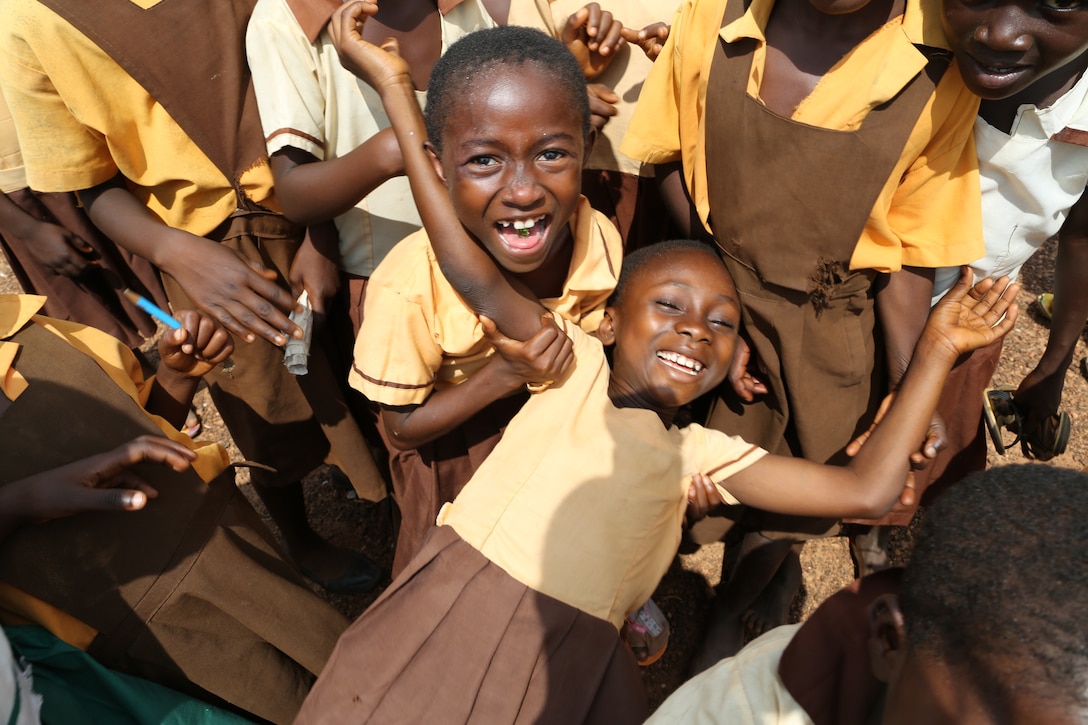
[329,0,415,93]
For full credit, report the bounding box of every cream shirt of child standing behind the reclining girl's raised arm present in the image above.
[246,0,495,277]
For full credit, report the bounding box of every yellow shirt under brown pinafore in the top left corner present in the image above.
[0,0,273,235]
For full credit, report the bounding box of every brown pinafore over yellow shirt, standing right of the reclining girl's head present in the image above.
[706,0,948,463]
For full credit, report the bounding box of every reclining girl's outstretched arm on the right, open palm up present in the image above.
[726,271,1019,518]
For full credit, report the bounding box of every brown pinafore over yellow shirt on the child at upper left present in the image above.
[42,0,385,501]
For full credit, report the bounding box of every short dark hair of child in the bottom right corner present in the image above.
[901,465,1088,711]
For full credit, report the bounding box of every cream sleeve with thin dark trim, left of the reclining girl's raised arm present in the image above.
[246,0,326,159]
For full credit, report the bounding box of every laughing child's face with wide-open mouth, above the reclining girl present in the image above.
[434,63,585,273]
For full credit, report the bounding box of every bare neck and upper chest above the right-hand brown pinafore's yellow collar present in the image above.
[759,0,906,116]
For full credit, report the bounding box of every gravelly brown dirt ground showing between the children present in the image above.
[6,236,1088,705]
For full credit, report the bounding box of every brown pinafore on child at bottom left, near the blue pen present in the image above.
[0,322,347,722]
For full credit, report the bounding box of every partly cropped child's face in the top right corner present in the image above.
[943,0,1088,100]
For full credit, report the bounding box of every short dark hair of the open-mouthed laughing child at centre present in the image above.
[424,25,590,150]
